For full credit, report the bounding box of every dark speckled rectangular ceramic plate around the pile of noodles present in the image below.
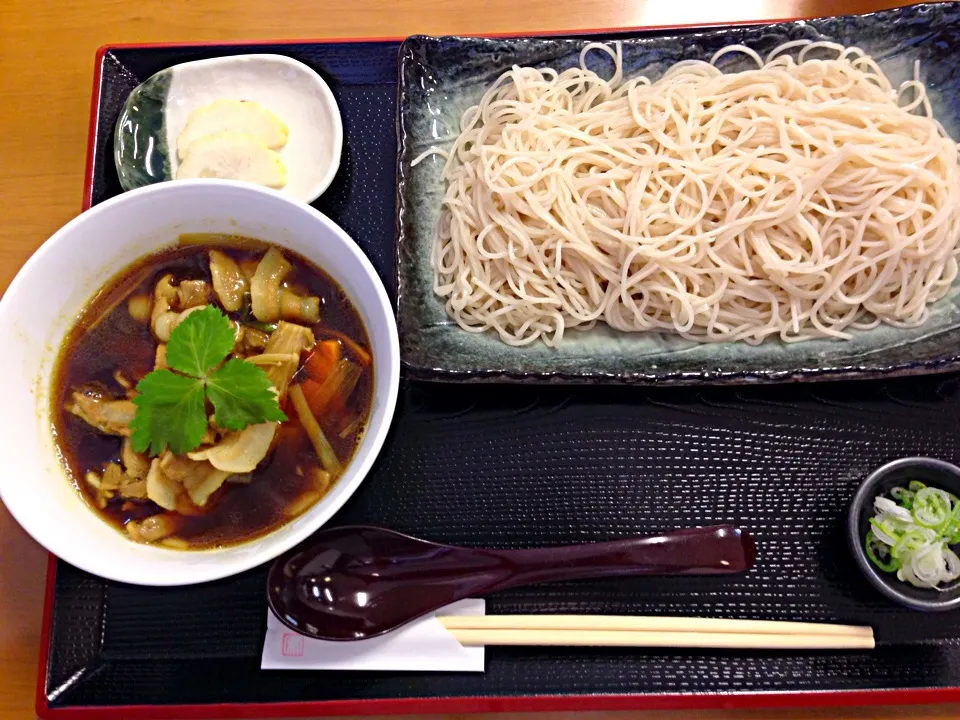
[397,3,960,384]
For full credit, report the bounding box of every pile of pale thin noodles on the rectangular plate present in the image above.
[417,41,960,346]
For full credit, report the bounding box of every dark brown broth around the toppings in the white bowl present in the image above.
[51,236,373,548]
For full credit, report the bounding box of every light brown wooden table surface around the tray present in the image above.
[0,0,960,720]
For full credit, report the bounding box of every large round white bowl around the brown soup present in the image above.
[0,180,400,585]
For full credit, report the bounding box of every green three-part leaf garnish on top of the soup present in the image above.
[130,305,287,456]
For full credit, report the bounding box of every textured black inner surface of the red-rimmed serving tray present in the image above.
[45,29,960,707]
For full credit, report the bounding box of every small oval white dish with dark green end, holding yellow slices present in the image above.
[114,54,343,203]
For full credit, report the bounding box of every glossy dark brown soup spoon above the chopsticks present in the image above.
[267,525,755,640]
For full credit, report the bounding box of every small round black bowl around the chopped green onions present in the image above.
[847,457,960,612]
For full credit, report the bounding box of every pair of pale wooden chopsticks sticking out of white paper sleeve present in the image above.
[437,615,875,650]
